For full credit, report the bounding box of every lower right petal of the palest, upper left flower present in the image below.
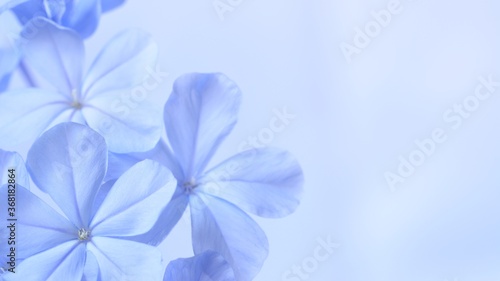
[82,90,162,153]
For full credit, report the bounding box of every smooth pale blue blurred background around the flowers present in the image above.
[2,0,500,281]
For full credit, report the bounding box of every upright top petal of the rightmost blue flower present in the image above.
[164,73,241,180]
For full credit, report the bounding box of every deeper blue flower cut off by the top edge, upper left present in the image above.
[0,0,125,38]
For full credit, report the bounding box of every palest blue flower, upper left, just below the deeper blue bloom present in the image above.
[0,18,162,153]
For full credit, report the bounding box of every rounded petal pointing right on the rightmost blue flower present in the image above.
[199,148,304,218]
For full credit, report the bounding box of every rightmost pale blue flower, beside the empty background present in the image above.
[131,74,303,281]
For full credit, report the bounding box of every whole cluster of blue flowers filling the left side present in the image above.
[0,0,303,281]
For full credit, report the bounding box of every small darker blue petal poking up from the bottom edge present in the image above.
[163,251,236,281]
